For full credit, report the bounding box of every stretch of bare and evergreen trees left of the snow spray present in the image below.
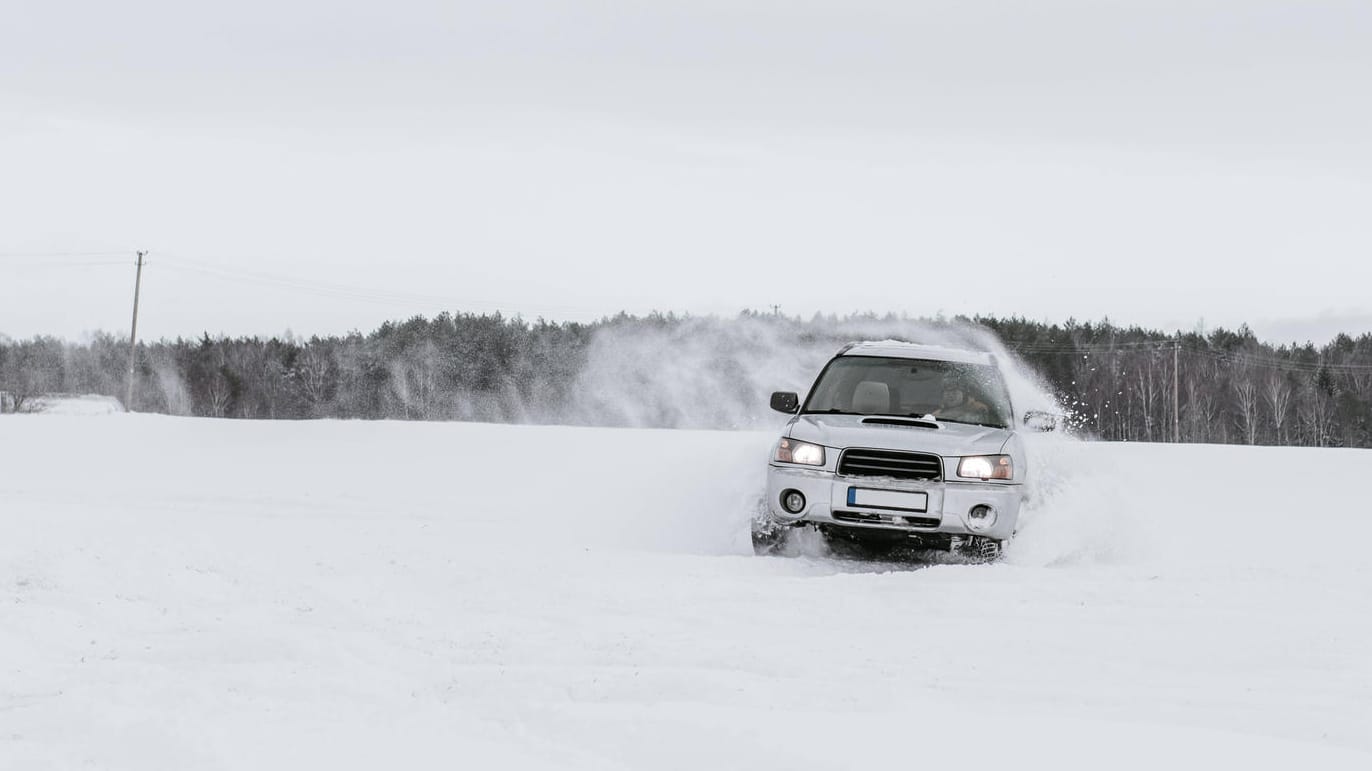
[0,314,593,421]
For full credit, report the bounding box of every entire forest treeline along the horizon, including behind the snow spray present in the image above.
[0,311,1372,447]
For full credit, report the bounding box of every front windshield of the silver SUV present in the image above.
[801,357,1010,428]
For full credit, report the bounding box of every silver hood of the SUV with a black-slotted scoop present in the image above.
[788,414,1011,455]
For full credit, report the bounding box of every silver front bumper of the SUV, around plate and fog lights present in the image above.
[767,464,1024,541]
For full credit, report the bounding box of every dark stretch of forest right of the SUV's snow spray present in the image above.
[977,318,1372,447]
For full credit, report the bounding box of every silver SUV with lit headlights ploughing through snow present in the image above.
[753,342,1033,561]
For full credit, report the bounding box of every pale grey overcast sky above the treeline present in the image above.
[0,0,1372,339]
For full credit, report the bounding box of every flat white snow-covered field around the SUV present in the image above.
[0,414,1372,771]
